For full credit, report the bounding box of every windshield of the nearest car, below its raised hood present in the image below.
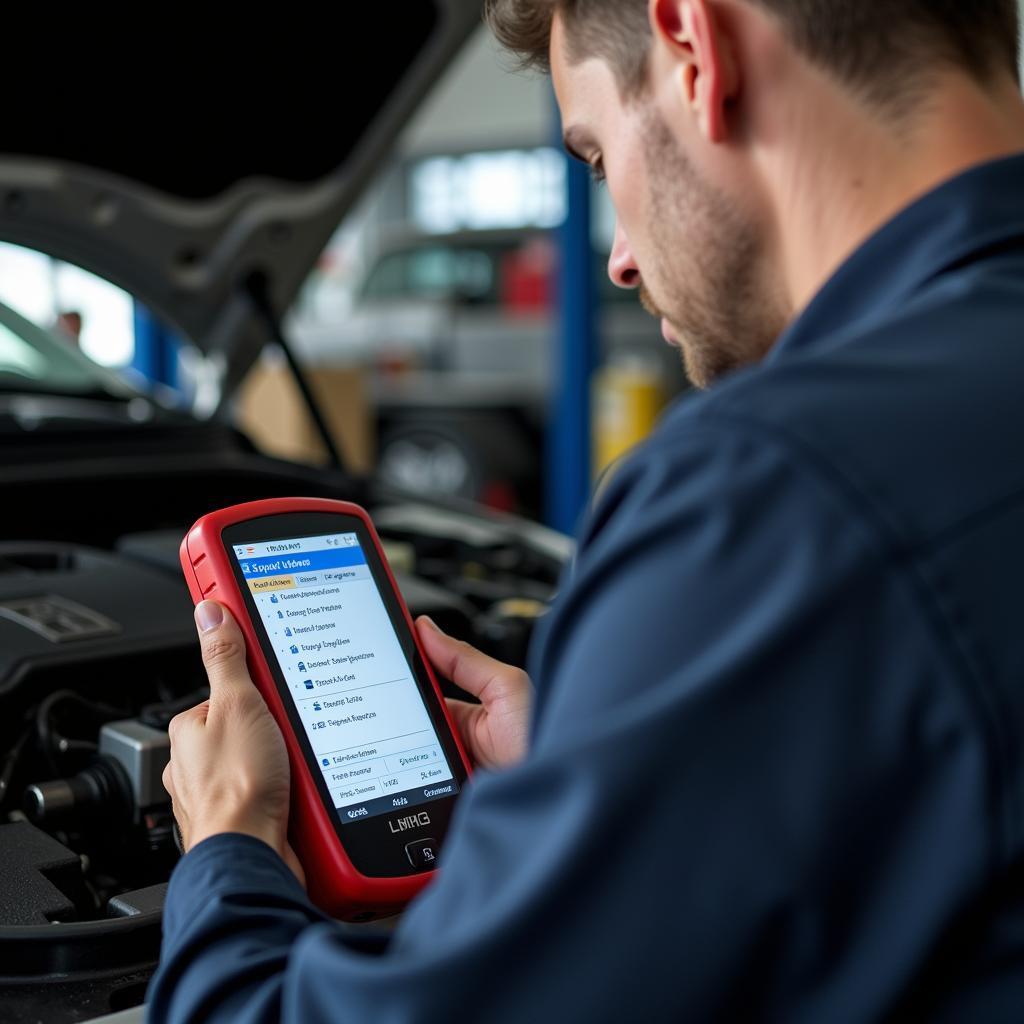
[0,303,140,399]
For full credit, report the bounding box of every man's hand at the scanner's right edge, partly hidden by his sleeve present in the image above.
[416,615,534,768]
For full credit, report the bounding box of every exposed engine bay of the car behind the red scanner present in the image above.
[0,421,569,1022]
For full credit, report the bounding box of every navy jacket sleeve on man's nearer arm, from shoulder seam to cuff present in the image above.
[150,422,990,1024]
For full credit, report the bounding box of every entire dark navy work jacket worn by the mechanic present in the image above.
[150,157,1024,1024]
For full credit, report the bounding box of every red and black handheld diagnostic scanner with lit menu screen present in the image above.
[180,498,469,921]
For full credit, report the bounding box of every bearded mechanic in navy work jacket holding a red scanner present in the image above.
[150,0,1024,1024]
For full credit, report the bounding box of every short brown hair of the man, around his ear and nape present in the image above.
[486,0,1020,108]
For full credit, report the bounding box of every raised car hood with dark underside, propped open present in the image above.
[0,0,482,393]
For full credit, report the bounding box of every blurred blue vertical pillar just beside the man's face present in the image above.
[545,104,597,532]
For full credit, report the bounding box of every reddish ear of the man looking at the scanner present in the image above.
[648,0,739,142]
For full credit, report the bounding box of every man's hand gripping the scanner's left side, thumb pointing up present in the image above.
[164,601,304,882]
